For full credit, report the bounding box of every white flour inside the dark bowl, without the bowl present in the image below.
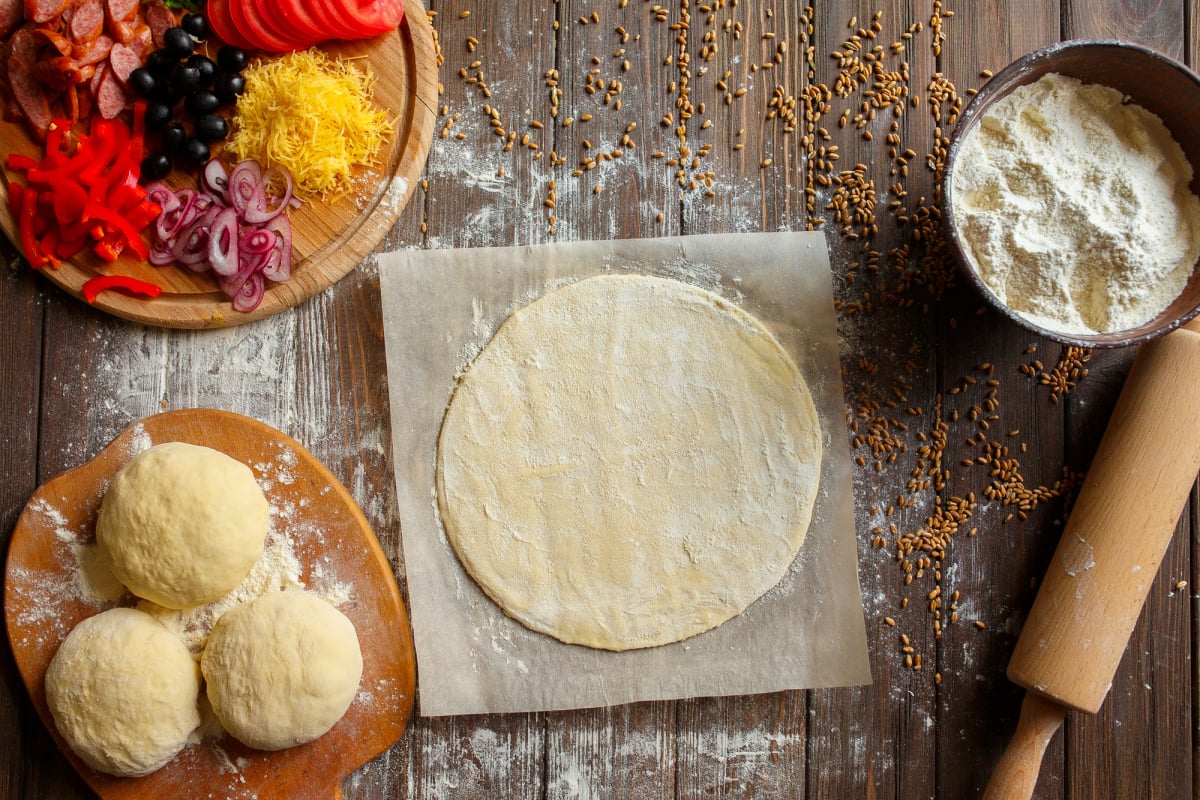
[953,74,1200,333]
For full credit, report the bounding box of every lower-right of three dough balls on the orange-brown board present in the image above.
[200,591,362,750]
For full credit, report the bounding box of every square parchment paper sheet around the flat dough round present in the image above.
[379,233,870,716]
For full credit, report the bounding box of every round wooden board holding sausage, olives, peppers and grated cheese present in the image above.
[0,9,438,327]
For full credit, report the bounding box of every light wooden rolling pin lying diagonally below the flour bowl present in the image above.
[984,319,1200,800]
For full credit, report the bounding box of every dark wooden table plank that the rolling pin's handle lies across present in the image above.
[937,2,1064,798]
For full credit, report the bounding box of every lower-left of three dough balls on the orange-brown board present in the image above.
[46,608,200,776]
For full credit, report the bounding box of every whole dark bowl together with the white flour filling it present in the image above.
[942,41,1200,347]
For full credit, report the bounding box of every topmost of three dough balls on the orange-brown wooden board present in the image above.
[96,441,270,608]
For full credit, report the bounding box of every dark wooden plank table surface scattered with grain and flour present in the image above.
[0,0,1200,800]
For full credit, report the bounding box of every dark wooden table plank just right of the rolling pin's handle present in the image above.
[1063,1,1194,799]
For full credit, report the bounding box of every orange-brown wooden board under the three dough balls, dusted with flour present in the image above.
[5,409,415,800]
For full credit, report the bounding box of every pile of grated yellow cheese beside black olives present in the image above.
[226,49,391,200]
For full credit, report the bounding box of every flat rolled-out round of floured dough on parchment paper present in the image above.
[437,276,822,650]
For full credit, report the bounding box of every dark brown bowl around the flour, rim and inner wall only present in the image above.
[942,40,1200,348]
